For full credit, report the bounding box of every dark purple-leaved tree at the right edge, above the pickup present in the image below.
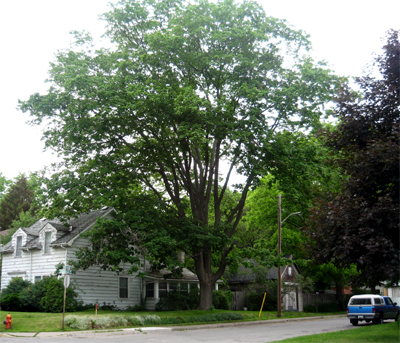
[308,31,400,289]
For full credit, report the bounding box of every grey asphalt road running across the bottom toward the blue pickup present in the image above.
[1,317,357,343]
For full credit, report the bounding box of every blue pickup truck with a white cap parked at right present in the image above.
[347,294,400,325]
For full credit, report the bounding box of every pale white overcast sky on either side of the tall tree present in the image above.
[0,0,400,178]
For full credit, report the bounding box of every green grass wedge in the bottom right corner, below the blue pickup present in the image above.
[274,321,400,343]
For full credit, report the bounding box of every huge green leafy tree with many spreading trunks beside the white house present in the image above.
[20,0,338,308]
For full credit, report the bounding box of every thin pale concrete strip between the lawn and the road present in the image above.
[1,314,346,338]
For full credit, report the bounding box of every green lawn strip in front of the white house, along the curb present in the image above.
[0,310,345,332]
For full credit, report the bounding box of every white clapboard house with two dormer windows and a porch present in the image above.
[0,207,199,310]
